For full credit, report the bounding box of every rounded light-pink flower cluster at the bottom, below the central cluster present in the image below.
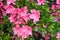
[12,25,32,38]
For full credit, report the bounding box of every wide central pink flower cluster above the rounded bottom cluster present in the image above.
[5,5,40,24]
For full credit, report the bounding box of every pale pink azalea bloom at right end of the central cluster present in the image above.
[30,9,40,23]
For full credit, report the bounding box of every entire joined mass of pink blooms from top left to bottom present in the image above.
[0,0,40,39]
